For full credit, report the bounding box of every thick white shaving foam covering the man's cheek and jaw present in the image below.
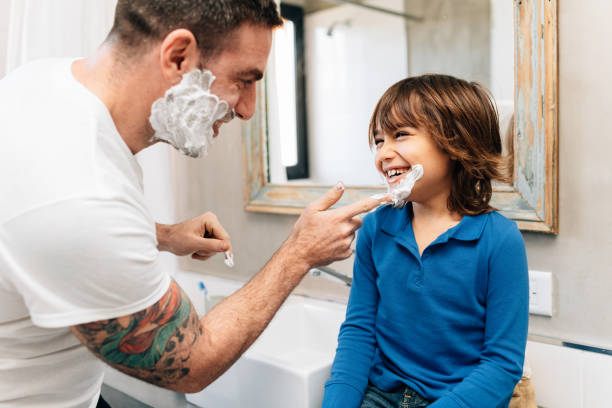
[149,69,235,157]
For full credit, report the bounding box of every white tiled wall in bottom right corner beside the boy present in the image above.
[526,341,612,408]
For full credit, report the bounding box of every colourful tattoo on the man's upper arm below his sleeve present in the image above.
[73,281,202,386]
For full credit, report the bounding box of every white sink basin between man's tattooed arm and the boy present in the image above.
[187,296,346,408]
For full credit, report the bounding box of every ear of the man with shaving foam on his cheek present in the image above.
[159,28,200,85]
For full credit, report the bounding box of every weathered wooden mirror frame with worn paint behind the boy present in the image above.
[242,0,559,234]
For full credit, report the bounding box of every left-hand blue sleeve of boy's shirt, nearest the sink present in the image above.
[322,214,379,408]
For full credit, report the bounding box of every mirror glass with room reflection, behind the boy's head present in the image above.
[266,0,514,186]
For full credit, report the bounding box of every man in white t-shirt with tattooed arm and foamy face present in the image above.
[0,0,388,407]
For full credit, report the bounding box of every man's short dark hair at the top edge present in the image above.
[109,0,283,58]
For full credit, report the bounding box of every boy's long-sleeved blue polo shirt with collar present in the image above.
[323,204,529,408]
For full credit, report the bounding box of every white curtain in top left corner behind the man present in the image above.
[5,0,117,73]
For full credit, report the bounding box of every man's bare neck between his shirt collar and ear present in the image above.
[72,44,161,154]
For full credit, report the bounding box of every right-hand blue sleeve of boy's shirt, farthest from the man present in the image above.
[430,225,529,408]
